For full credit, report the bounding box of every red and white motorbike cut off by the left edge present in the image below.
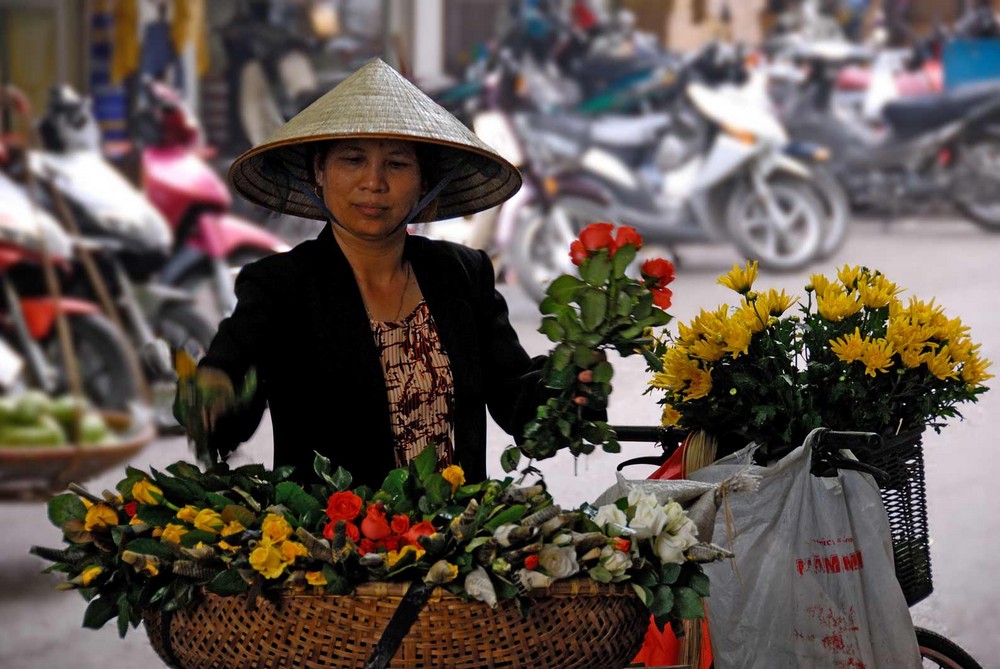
[0,166,139,410]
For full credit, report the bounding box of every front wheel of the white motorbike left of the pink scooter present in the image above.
[150,302,215,434]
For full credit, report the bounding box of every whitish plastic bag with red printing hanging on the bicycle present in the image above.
[691,432,921,669]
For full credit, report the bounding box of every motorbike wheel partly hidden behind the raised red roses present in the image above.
[510,196,606,302]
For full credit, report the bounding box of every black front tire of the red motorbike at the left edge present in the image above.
[41,314,141,411]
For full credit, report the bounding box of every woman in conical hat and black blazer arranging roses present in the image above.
[191,60,589,486]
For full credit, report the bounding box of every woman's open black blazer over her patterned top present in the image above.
[201,224,546,487]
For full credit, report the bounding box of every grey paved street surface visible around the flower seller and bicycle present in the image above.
[0,219,1000,669]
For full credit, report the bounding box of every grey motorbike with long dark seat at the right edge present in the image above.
[782,47,1000,231]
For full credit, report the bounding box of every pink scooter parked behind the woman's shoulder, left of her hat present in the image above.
[135,81,289,318]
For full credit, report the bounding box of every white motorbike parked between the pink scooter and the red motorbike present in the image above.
[28,86,215,429]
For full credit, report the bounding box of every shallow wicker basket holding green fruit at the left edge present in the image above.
[0,411,156,501]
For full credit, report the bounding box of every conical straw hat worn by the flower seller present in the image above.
[229,58,521,220]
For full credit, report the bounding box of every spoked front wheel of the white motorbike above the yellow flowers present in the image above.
[725,175,824,272]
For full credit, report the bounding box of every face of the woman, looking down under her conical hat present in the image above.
[316,139,423,241]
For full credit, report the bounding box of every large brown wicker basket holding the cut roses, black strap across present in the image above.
[144,578,649,669]
